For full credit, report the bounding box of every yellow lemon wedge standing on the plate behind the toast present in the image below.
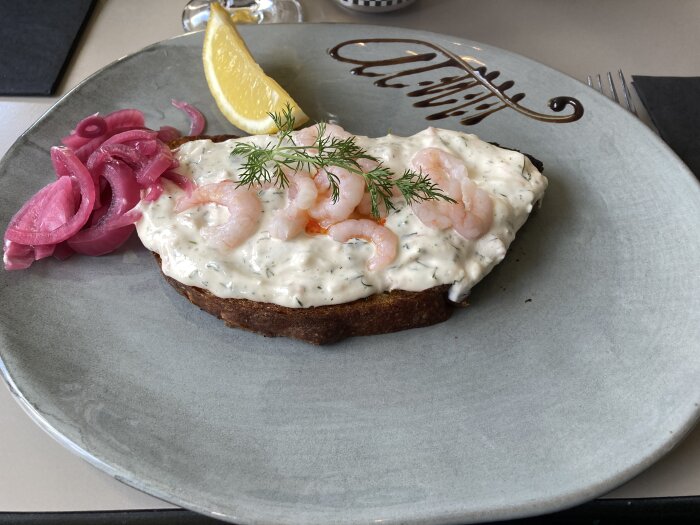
[202,2,309,134]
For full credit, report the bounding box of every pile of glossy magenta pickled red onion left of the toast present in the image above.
[3,101,205,270]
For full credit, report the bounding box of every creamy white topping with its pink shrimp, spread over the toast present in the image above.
[137,126,547,308]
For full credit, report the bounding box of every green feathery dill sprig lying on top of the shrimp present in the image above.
[231,105,455,217]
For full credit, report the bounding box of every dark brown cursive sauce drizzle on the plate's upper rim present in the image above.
[328,38,583,126]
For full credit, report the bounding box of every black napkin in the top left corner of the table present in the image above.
[0,0,95,95]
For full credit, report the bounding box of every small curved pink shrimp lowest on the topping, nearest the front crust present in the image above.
[328,219,399,270]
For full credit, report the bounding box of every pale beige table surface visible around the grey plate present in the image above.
[0,0,700,512]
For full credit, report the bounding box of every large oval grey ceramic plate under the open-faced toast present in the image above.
[0,25,700,524]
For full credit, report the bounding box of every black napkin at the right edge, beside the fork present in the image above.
[632,76,700,178]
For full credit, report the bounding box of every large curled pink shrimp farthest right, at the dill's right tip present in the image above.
[411,148,493,240]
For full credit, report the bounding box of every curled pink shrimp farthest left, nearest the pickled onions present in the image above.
[175,180,262,250]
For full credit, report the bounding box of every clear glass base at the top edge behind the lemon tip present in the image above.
[182,0,303,32]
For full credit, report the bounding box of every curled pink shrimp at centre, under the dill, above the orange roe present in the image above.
[309,166,365,228]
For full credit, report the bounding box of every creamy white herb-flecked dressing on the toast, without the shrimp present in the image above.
[136,128,547,308]
